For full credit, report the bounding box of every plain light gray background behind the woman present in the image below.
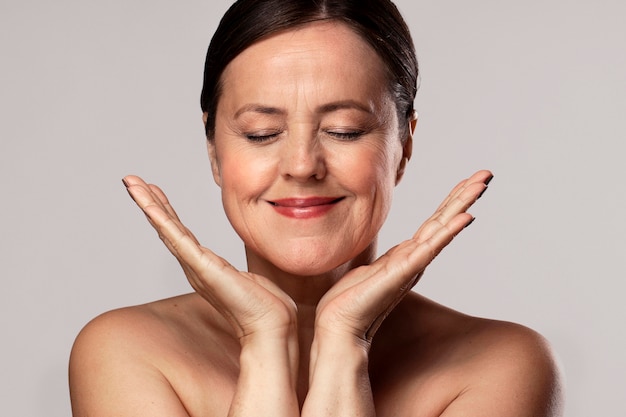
[0,0,626,417]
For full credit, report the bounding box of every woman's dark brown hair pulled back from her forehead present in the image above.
[200,0,418,140]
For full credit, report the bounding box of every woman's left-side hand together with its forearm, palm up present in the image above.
[124,176,299,417]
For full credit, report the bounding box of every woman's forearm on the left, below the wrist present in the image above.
[229,337,299,417]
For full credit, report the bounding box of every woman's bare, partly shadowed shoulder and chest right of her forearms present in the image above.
[368,295,562,417]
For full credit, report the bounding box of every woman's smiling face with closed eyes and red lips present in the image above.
[209,23,411,275]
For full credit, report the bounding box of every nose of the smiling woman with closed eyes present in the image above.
[280,129,326,182]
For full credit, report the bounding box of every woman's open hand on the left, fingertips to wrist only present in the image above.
[123,175,296,344]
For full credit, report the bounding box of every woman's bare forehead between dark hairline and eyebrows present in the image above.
[217,22,387,109]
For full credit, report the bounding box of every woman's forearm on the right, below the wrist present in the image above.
[302,336,375,417]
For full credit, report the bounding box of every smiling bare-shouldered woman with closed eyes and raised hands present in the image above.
[70,0,559,417]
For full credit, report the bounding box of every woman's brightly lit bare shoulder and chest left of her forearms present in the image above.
[69,296,234,416]
